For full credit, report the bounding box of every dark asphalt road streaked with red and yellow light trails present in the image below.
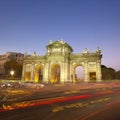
[0,83,120,120]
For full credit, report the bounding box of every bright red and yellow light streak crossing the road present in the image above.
[0,94,92,112]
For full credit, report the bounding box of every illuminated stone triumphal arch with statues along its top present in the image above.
[22,40,102,83]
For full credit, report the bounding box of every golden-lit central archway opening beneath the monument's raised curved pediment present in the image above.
[50,64,60,83]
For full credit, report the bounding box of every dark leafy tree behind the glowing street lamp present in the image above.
[4,58,23,79]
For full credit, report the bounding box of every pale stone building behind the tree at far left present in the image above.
[0,52,24,78]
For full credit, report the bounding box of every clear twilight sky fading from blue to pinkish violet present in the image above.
[0,0,120,70]
